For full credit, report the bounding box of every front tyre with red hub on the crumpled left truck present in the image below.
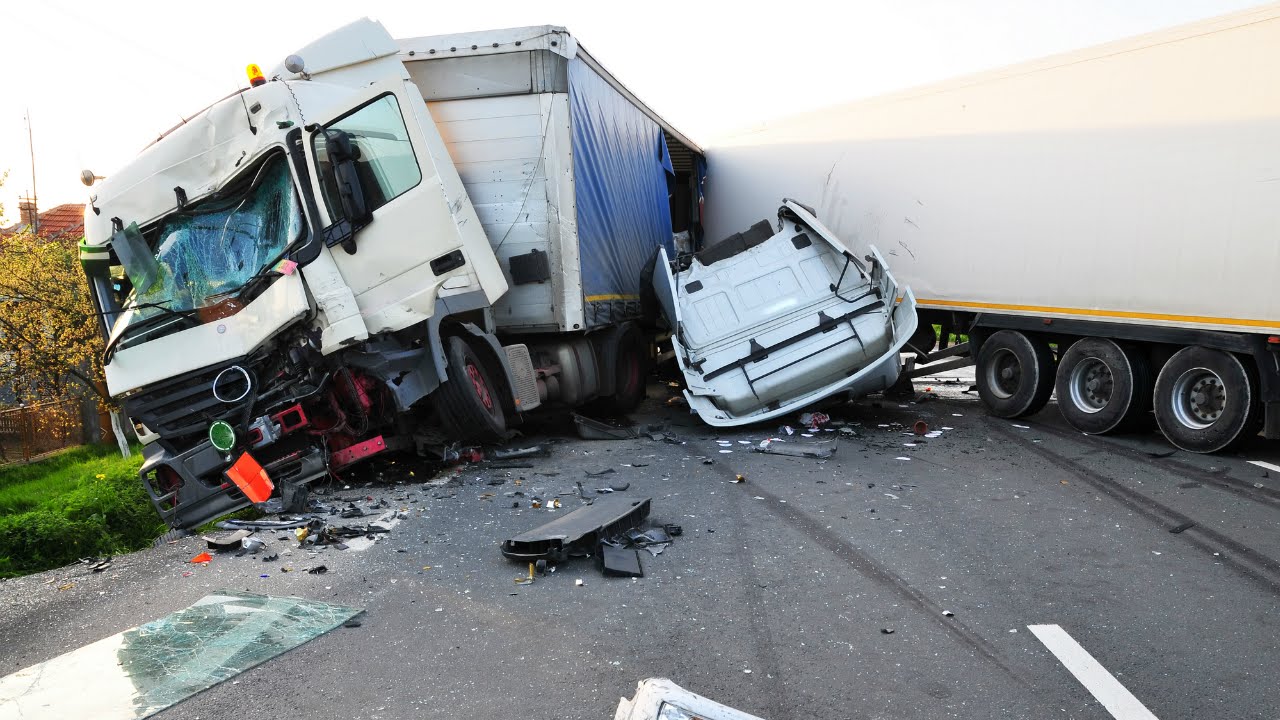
[433,336,507,442]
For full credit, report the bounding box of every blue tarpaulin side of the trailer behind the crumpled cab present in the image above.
[568,59,675,328]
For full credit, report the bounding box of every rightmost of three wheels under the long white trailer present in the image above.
[1155,346,1262,452]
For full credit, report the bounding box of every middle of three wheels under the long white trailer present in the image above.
[1055,337,1152,436]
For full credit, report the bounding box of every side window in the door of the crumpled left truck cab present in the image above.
[311,95,422,219]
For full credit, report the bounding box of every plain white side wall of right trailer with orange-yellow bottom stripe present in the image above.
[707,5,1280,333]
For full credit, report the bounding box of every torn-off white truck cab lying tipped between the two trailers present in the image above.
[654,200,916,427]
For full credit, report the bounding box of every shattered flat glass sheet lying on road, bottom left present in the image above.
[0,591,361,720]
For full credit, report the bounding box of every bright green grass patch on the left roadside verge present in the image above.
[0,445,165,577]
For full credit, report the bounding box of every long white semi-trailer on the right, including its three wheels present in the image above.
[707,5,1280,452]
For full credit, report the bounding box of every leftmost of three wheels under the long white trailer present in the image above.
[977,331,1053,418]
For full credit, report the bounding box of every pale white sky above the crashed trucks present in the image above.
[0,0,1263,225]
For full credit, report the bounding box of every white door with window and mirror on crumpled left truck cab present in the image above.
[305,79,506,334]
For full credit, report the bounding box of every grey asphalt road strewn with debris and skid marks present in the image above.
[0,382,1280,720]
